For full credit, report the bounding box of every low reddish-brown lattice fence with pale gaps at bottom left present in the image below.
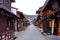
[0,31,14,40]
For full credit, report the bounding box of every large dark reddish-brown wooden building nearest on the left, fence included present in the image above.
[0,0,18,40]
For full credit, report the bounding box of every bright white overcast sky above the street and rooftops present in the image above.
[12,0,46,15]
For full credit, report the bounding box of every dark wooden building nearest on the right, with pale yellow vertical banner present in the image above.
[43,0,60,36]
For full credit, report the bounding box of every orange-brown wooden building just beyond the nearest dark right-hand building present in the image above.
[36,7,44,28]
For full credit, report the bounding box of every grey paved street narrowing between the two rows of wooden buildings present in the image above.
[16,24,49,40]
